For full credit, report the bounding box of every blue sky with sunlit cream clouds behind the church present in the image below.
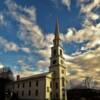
[0,0,100,84]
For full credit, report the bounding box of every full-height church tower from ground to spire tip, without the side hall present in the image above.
[49,19,67,100]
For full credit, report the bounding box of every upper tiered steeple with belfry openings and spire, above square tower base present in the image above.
[51,19,64,66]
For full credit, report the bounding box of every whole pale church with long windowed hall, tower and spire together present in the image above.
[8,20,67,100]
